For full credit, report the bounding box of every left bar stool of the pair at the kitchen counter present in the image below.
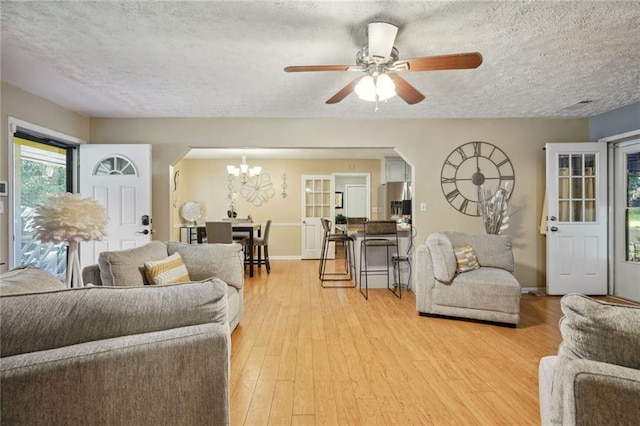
[318,218,356,288]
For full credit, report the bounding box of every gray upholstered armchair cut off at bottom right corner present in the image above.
[538,294,640,426]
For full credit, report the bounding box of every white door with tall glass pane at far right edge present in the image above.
[613,140,640,302]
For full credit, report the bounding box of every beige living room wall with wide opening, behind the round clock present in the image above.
[0,83,589,287]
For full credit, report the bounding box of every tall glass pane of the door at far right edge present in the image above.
[625,152,640,262]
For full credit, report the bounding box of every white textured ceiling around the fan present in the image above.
[1,0,640,118]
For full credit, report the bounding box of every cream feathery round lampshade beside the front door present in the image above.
[28,192,109,244]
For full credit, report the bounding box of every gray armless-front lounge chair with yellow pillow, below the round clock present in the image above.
[415,232,521,327]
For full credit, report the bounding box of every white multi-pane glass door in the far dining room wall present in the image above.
[301,175,336,259]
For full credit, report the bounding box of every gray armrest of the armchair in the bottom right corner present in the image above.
[562,359,640,425]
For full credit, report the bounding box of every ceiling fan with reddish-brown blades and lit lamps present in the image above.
[284,22,482,111]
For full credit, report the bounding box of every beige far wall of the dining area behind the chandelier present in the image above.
[170,157,380,258]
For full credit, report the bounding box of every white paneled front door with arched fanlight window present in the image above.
[79,144,151,267]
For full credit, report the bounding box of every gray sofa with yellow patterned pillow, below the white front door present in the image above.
[82,241,244,332]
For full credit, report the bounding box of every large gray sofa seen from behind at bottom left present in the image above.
[0,268,231,426]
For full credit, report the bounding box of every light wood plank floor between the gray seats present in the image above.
[230,261,561,426]
